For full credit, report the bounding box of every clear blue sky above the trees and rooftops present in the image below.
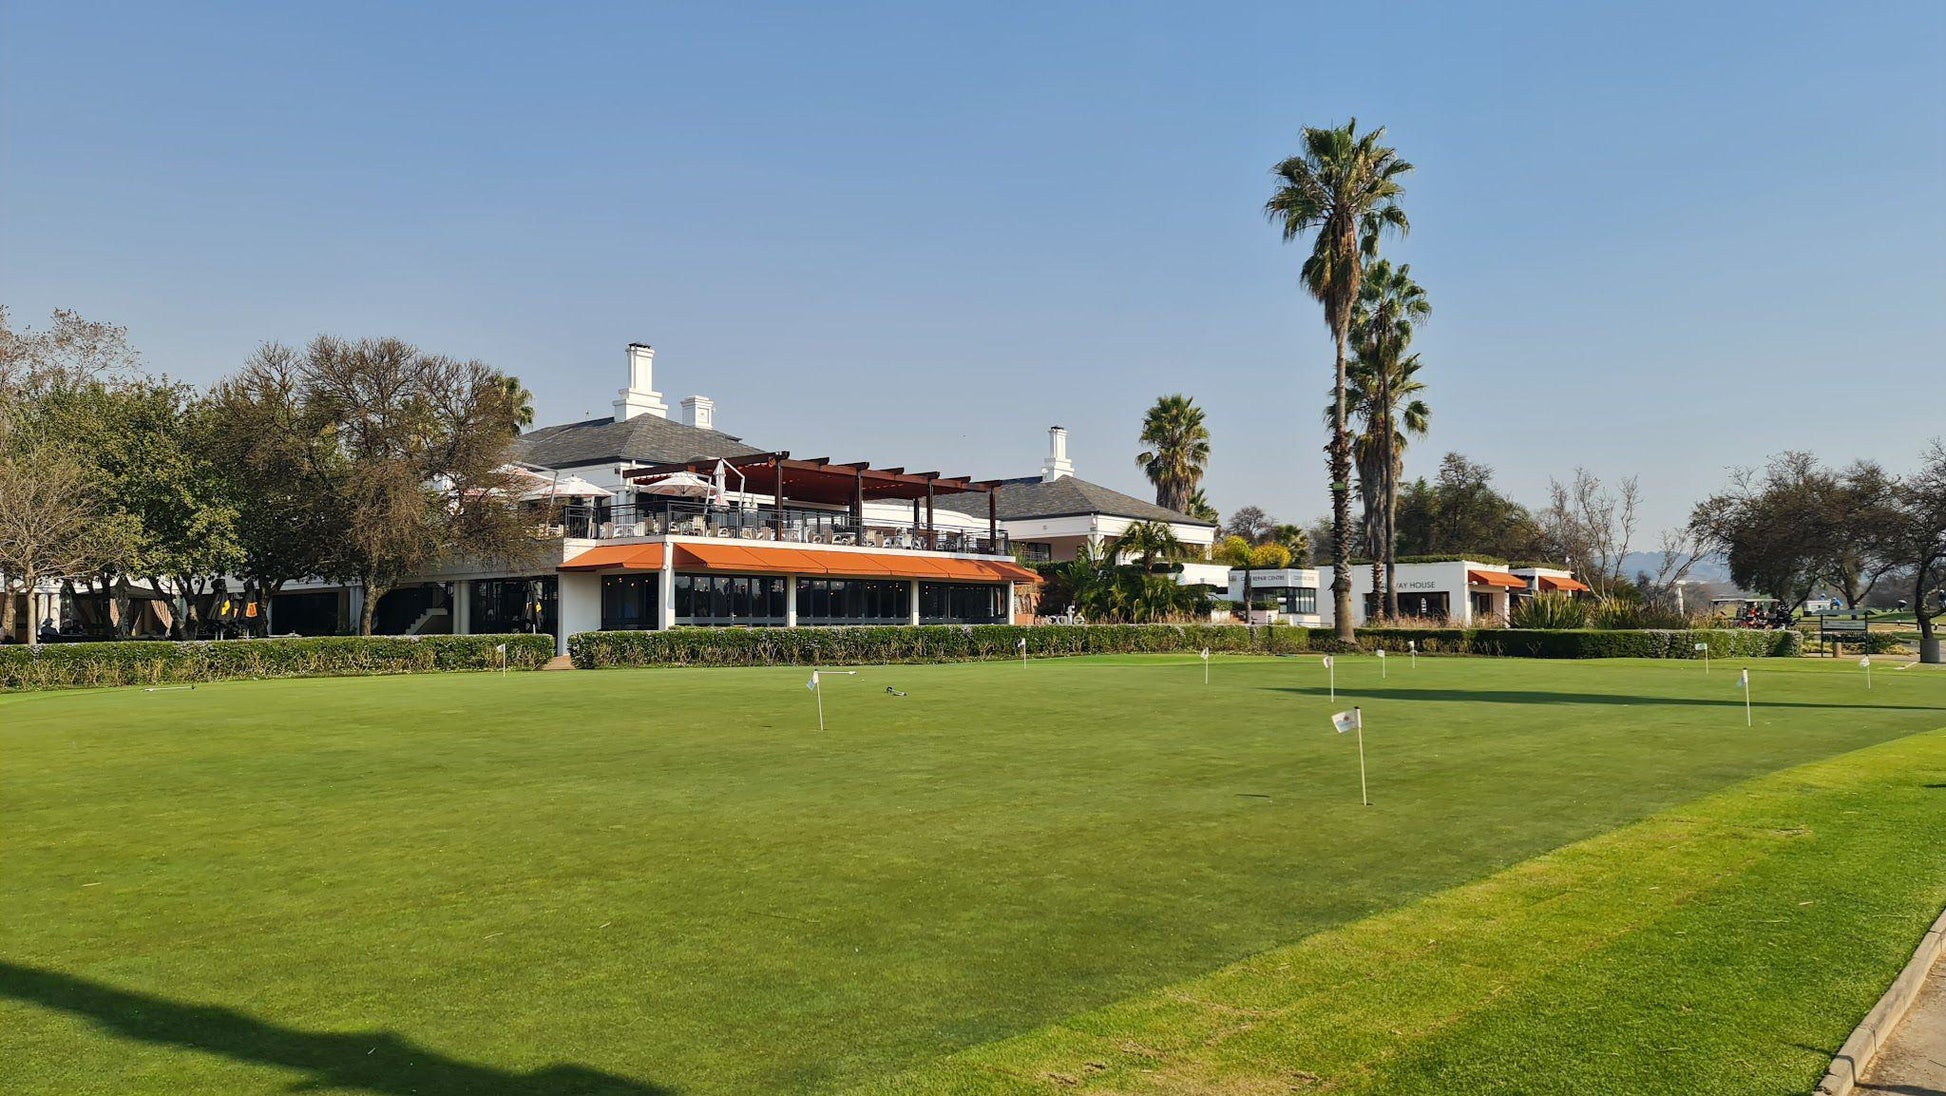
[0,0,1946,526]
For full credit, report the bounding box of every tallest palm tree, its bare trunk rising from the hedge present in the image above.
[1263,119,1413,642]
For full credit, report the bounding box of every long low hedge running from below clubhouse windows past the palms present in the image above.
[568,625,1802,670]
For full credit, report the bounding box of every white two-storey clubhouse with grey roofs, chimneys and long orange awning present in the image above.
[269,343,1216,652]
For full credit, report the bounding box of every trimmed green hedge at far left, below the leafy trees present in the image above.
[0,635,555,689]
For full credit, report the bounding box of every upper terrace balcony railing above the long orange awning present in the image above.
[543,498,1012,555]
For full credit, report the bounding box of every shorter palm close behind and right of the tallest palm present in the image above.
[1351,259,1432,617]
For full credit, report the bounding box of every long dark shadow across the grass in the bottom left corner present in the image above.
[0,960,675,1096]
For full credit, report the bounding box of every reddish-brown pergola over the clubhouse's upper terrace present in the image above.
[627,452,1004,547]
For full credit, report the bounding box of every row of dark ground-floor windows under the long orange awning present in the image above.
[601,574,1006,631]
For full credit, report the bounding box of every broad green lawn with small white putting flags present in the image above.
[0,658,1946,1094]
